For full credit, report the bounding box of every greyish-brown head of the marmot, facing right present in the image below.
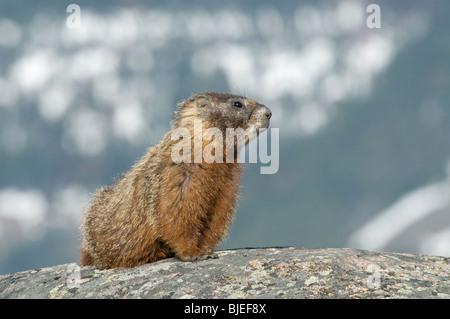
[173,92,272,134]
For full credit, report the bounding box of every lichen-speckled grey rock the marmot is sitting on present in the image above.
[0,247,450,299]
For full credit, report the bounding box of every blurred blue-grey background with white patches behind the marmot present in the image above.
[0,0,450,274]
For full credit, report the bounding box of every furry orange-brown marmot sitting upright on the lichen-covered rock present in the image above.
[81,92,271,268]
